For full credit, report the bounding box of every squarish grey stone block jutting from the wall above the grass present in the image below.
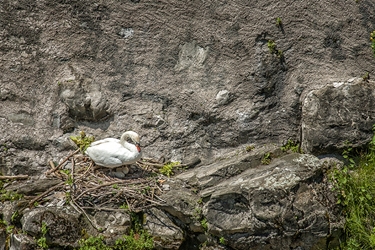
[302,78,375,153]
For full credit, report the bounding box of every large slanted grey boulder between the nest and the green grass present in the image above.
[169,149,343,249]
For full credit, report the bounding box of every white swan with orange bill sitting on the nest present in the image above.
[86,131,142,168]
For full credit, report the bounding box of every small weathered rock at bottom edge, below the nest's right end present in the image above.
[143,208,185,249]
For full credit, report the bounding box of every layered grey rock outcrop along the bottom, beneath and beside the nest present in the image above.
[1,145,343,250]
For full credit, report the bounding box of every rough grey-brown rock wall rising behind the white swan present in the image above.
[0,0,375,172]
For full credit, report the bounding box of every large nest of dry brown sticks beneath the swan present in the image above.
[12,149,172,231]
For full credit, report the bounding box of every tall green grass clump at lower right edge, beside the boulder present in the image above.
[330,127,375,250]
